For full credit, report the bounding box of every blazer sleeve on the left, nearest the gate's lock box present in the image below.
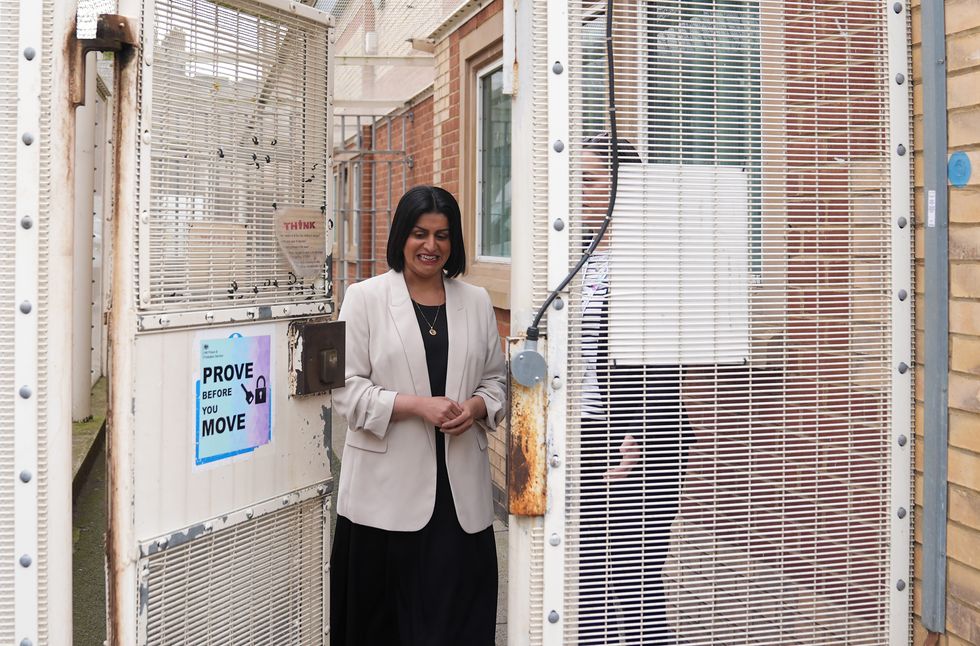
[333,285,398,438]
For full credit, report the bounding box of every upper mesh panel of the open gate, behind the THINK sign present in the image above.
[139,0,329,312]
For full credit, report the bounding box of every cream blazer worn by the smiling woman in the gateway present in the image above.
[333,271,505,534]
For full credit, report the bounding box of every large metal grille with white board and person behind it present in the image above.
[563,0,908,644]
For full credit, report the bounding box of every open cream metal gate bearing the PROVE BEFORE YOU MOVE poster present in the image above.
[108,0,343,646]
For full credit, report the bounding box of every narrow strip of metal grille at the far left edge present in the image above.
[0,0,20,643]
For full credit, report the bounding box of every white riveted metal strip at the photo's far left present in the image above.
[14,0,42,643]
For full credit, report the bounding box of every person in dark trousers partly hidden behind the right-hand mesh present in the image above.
[578,134,693,646]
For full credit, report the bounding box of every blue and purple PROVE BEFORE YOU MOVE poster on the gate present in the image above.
[195,334,272,465]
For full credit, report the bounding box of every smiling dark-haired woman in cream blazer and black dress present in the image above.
[330,186,505,646]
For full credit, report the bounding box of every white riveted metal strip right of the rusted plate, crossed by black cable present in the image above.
[542,2,571,646]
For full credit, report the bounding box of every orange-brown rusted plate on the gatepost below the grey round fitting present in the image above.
[507,339,548,516]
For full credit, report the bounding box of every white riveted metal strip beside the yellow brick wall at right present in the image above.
[882,2,915,645]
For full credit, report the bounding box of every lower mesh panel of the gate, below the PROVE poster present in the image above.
[140,497,327,646]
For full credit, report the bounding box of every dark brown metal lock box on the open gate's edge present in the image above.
[289,319,346,396]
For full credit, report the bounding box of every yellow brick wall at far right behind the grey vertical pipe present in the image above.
[912,0,980,646]
